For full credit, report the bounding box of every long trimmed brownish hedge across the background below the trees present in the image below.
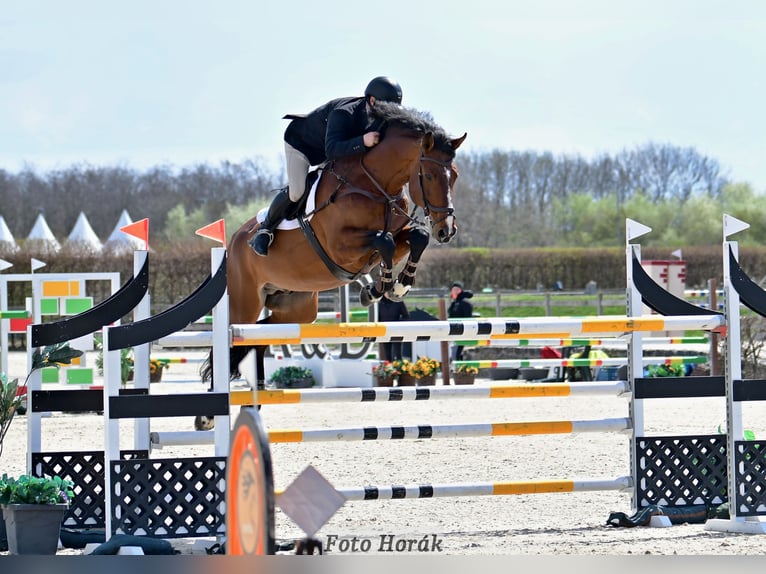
[0,244,766,311]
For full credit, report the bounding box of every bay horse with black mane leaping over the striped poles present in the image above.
[202,102,467,428]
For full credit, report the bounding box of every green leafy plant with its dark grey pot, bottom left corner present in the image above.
[0,474,74,554]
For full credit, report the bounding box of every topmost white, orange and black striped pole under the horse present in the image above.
[231,315,725,345]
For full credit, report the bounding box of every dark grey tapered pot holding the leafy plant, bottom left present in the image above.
[3,504,69,555]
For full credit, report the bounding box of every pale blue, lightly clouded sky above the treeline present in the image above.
[0,0,766,193]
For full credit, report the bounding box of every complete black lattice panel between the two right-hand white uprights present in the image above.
[635,435,727,508]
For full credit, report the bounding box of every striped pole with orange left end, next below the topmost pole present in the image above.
[230,381,630,406]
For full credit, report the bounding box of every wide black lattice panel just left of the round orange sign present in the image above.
[111,457,226,538]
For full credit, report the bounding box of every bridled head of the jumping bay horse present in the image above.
[410,132,468,243]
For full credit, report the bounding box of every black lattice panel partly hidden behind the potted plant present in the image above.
[32,450,149,529]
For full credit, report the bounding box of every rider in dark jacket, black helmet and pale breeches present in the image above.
[250,76,402,256]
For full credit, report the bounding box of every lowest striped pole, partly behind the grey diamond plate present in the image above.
[276,476,633,501]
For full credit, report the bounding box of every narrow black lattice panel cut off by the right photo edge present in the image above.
[734,441,766,516]
